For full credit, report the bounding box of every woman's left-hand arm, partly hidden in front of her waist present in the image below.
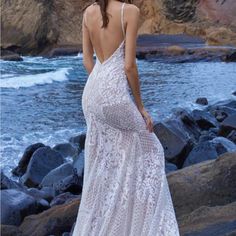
[82,9,94,74]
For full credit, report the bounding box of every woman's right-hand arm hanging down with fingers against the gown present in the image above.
[125,5,153,132]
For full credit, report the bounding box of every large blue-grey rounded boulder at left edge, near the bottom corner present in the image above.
[1,189,45,226]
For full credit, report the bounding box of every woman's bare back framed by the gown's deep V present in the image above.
[85,1,125,62]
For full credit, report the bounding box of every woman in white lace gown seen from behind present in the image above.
[72,0,179,236]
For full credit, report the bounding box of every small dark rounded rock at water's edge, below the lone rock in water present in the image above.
[192,109,218,130]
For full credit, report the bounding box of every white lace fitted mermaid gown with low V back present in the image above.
[72,4,179,236]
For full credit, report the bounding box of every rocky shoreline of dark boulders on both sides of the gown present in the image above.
[1,93,236,236]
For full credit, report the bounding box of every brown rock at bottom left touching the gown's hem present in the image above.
[19,199,80,236]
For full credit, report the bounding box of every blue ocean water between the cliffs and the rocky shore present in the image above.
[0,54,236,179]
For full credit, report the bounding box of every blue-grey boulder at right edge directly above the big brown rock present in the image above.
[183,137,236,167]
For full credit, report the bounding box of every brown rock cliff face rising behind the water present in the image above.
[1,0,236,54]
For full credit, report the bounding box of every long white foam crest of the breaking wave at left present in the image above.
[0,68,70,89]
